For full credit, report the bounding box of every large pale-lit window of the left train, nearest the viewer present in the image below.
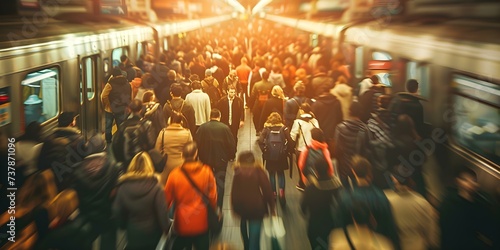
[21,68,59,126]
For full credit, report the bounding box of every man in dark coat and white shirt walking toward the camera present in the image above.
[217,85,245,145]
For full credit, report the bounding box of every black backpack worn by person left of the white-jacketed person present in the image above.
[264,126,287,161]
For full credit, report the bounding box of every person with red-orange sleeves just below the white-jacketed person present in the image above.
[298,128,333,186]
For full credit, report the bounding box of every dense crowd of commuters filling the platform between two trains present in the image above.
[0,19,499,250]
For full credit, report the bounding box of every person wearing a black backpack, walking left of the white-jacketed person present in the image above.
[259,112,288,204]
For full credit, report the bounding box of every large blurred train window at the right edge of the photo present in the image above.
[453,75,500,164]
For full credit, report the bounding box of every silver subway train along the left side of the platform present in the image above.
[0,13,232,141]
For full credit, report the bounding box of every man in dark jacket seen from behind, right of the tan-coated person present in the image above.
[195,109,236,209]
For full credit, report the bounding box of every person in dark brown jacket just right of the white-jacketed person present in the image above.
[311,88,343,154]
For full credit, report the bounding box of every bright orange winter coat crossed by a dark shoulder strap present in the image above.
[164,162,217,236]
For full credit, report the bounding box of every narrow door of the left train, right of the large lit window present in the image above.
[80,55,101,139]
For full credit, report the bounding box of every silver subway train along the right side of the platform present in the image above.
[265,15,500,196]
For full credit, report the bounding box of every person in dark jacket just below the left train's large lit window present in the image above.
[38,112,86,191]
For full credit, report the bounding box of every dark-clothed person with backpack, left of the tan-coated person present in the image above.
[112,100,156,166]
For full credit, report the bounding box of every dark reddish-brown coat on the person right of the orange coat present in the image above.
[231,166,275,220]
